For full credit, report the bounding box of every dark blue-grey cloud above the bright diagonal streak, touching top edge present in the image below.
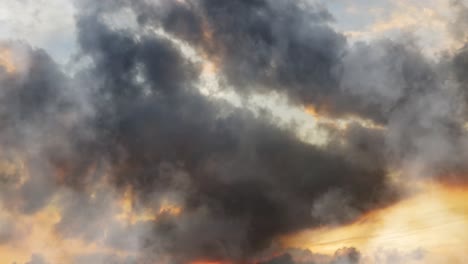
[132,0,454,124]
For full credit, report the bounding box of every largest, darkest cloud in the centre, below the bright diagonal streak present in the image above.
[57,4,389,262]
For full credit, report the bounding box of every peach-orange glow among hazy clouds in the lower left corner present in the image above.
[0,186,182,263]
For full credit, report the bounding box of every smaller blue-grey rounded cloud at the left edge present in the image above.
[0,42,85,213]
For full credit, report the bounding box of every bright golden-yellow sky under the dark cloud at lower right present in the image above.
[283,180,468,263]
